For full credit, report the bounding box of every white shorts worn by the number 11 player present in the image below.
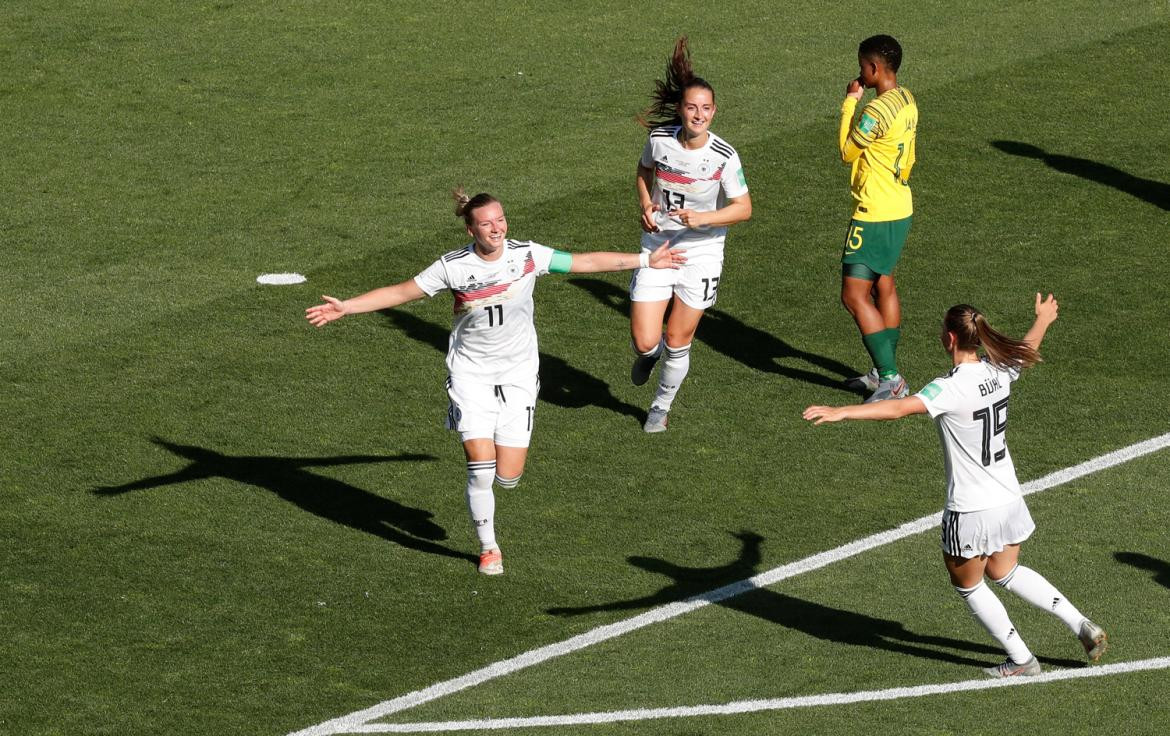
[447,376,541,447]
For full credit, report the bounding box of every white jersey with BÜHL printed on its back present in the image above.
[915,358,1023,513]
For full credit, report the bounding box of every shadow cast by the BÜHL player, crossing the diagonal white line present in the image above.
[548,531,1083,667]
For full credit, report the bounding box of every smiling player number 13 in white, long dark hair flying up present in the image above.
[629,36,751,432]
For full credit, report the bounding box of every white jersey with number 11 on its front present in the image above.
[414,240,556,384]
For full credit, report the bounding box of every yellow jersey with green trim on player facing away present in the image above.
[838,87,918,222]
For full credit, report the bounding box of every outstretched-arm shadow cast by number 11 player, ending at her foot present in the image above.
[92,438,479,562]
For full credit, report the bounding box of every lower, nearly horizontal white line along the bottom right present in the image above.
[355,656,1170,734]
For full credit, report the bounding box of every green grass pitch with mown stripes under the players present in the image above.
[0,0,1170,736]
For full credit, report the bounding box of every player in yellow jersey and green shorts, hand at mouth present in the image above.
[838,35,918,401]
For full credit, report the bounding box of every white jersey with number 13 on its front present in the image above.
[640,125,748,263]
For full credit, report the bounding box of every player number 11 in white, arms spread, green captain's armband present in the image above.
[305,188,686,575]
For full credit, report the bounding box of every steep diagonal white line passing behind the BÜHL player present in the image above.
[289,433,1170,736]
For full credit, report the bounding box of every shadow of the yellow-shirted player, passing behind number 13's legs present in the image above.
[569,278,868,395]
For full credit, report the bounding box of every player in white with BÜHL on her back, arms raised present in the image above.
[804,294,1107,677]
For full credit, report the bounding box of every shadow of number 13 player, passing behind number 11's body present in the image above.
[379,309,646,421]
